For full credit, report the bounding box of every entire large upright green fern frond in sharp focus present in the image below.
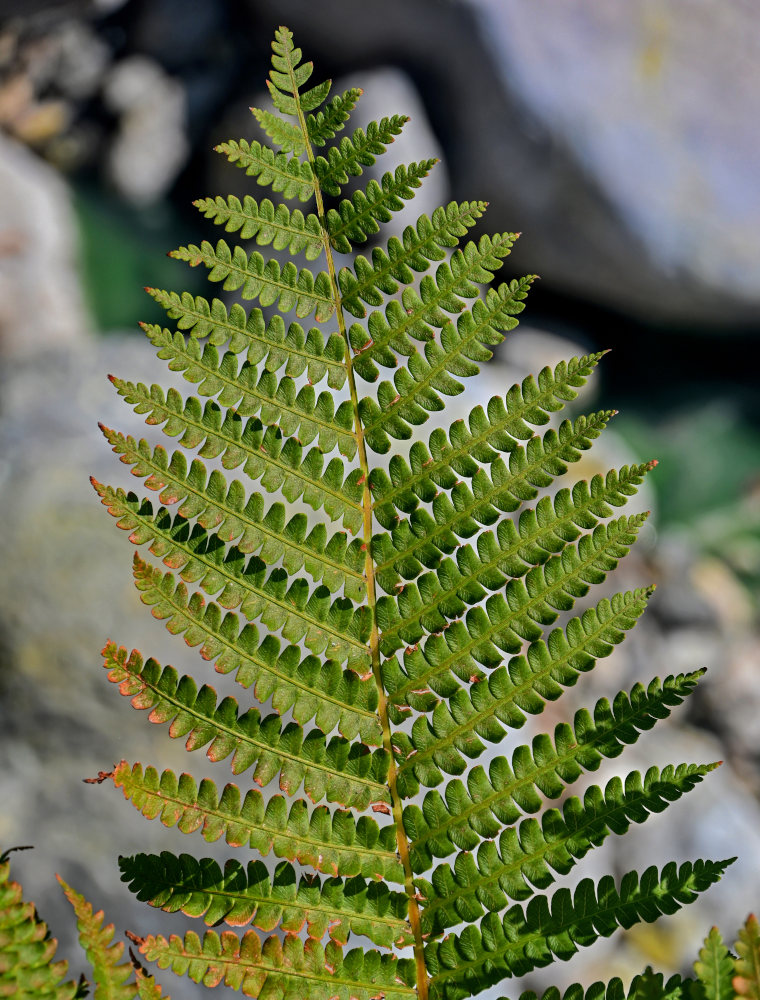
[95,28,726,1000]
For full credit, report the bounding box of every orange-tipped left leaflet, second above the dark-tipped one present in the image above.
[103,642,389,809]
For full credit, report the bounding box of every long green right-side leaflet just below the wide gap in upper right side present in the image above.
[369,353,610,528]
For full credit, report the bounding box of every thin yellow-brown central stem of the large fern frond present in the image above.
[288,50,428,1000]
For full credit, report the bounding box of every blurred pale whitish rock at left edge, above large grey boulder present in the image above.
[0,133,90,359]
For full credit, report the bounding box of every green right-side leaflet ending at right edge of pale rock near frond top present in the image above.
[325,160,440,252]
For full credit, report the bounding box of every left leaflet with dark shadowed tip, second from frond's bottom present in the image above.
[119,851,412,948]
